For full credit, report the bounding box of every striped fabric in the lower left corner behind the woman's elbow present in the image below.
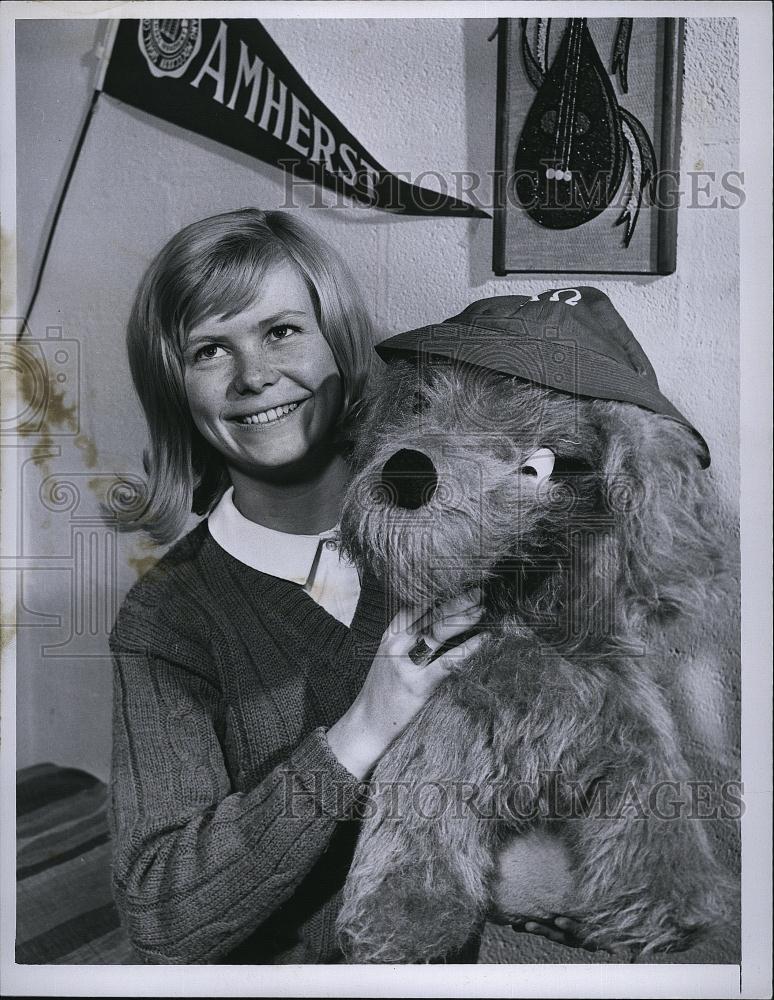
[16,764,138,965]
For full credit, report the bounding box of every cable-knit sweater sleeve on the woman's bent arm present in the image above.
[110,612,360,964]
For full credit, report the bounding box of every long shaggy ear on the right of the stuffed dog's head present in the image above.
[596,403,721,633]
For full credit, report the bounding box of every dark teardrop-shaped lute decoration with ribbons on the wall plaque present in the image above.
[514,17,656,247]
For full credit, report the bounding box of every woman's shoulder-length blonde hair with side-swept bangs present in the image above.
[121,208,373,542]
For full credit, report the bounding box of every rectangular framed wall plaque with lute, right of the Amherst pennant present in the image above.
[493,18,683,275]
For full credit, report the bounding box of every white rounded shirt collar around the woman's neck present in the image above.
[207,486,336,586]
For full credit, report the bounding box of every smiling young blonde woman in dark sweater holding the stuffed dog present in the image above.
[110,209,584,964]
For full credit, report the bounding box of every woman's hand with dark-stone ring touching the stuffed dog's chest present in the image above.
[328,588,484,780]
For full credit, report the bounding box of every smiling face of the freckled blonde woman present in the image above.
[183,263,342,480]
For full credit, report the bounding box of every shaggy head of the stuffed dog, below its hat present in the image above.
[342,300,718,652]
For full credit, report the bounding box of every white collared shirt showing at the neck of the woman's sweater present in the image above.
[208,486,360,626]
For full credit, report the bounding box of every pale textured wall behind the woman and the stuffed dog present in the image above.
[10,19,739,960]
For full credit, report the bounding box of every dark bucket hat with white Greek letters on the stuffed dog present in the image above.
[376,285,710,468]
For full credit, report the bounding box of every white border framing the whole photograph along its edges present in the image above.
[0,0,772,997]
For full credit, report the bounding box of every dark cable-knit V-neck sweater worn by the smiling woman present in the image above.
[109,522,388,964]
